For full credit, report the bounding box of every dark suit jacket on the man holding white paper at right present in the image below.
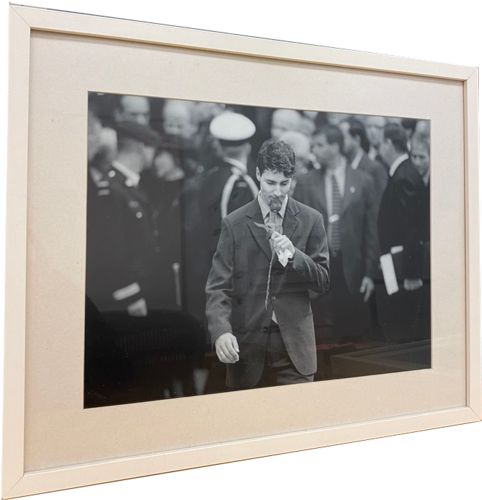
[378,159,427,280]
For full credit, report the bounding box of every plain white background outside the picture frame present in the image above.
[0,0,482,500]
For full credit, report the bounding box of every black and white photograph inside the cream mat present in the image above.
[84,92,431,408]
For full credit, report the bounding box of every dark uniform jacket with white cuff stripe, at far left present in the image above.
[86,164,160,313]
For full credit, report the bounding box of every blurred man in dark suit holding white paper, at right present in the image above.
[378,123,426,342]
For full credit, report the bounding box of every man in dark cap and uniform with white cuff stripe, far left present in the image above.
[87,122,159,316]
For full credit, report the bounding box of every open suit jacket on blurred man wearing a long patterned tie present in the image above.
[293,166,378,294]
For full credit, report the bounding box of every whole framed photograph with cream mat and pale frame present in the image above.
[2,6,481,498]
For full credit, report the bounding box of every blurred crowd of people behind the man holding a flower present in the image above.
[86,93,430,405]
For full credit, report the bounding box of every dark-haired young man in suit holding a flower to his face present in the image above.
[206,139,329,389]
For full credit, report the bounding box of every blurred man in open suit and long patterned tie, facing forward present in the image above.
[294,125,377,343]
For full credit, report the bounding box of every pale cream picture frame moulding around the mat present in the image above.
[2,6,482,498]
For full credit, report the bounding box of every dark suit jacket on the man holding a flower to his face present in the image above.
[206,198,329,387]
